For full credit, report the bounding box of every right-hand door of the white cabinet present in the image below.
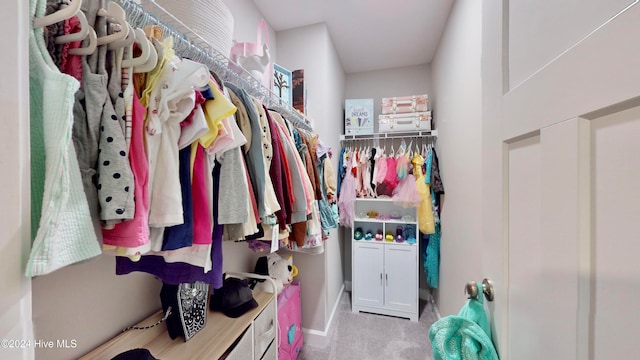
[384,244,418,312]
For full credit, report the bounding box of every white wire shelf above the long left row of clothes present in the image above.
[112,0,313,131]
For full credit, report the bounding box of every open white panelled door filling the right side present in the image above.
[482,0,640,360]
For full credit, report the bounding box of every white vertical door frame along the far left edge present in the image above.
[0,0,34,359]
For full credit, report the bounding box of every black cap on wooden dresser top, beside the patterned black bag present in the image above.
[210,277,258,318]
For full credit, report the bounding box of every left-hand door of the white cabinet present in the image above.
[352,241,384,306]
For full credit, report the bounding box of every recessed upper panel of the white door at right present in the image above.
[508,0,636,88]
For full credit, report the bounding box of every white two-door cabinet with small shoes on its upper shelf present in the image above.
[351,199,419,321]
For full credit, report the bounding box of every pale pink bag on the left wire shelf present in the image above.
[229,19,273,90]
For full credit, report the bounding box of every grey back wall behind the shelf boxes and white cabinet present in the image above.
[340,64,433,288]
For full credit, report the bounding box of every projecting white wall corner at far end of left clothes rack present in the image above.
[276,24,344,333]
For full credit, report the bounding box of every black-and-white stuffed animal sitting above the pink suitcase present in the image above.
[254,253,298,294]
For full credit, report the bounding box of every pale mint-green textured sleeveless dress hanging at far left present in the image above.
[25,0,101,277]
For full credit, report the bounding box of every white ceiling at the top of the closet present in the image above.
[253,0,454,73]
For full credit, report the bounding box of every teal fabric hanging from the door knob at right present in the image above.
[429,284,499,360]
